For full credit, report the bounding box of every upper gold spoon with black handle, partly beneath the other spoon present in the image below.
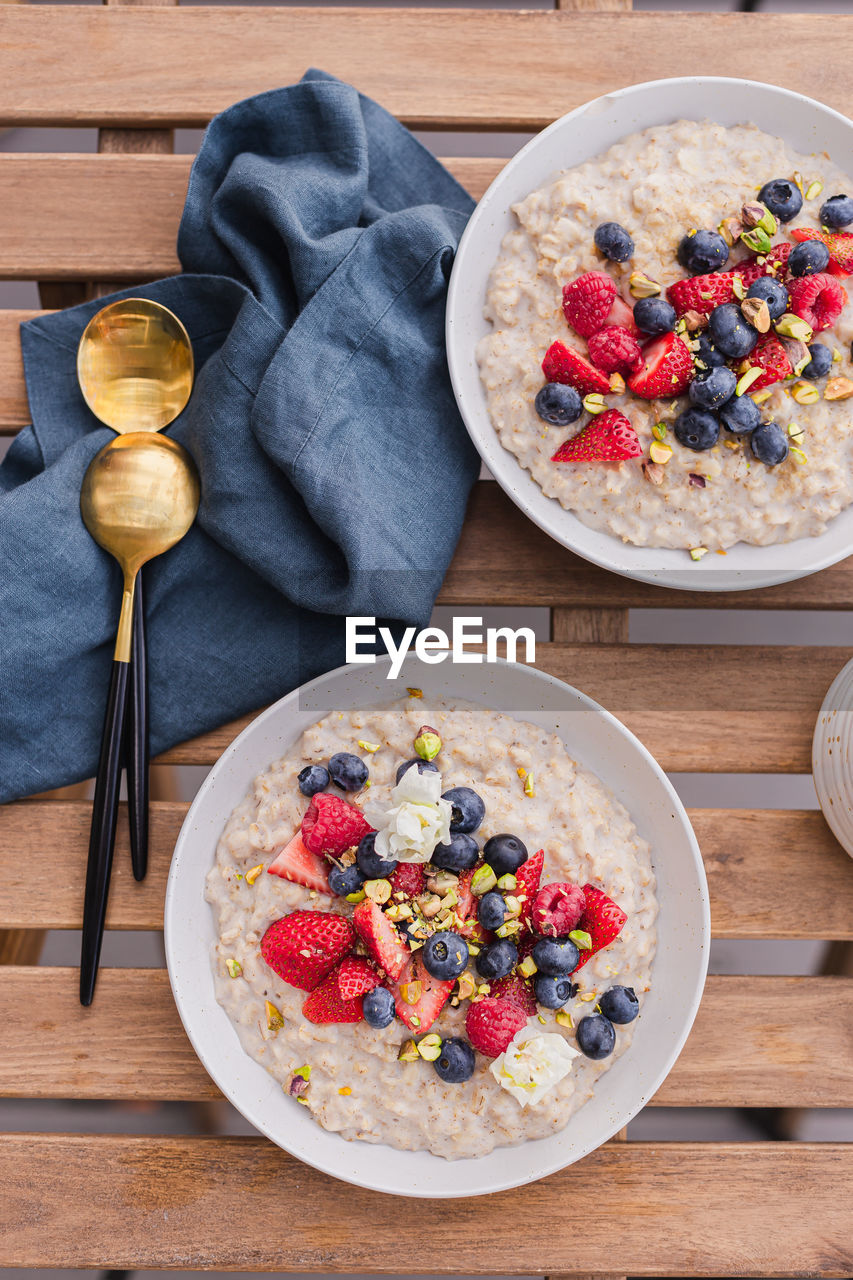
[77,298,193,881]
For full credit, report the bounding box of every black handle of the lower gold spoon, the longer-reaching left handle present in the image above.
[79,662,128,1005]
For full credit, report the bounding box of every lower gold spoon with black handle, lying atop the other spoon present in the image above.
[79,431,200,1005]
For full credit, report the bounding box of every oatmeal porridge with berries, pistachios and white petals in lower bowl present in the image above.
[206,692,657,1158]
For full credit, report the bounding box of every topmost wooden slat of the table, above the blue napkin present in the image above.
[0,5,853,129]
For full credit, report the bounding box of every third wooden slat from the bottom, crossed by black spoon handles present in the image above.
[0,800,853,936]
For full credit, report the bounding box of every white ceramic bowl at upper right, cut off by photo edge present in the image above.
[446,77,853,591]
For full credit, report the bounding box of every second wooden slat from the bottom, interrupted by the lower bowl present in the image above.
[0,968,853,1107]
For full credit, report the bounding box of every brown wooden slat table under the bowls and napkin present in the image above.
[0,0,853,1276]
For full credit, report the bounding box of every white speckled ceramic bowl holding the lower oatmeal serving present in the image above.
[165,662,710,1198]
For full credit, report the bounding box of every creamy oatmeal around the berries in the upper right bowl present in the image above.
[478,120,853,549]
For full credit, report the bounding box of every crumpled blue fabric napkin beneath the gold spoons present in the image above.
[0,72,478,801]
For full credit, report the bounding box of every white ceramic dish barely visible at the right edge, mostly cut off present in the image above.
[812,662,853,858]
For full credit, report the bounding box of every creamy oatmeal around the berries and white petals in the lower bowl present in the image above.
[206,696,657,1158]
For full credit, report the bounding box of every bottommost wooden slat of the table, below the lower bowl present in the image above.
[0,1134,853,1276]
